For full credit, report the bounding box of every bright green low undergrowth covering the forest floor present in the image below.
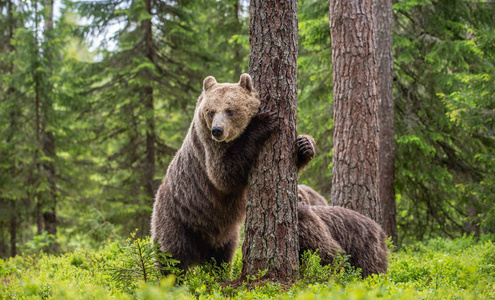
[0,237,495,299]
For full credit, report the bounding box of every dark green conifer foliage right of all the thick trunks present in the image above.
[394,1,495,241]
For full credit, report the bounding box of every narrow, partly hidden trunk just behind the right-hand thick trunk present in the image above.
[373,0,397,245]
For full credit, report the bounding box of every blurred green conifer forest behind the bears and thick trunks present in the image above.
[0,0,495,257]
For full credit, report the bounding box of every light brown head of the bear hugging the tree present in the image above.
[198,74,260,142]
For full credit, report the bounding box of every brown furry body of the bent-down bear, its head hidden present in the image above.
[298,204,388,278]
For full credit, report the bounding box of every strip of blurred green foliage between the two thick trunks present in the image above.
[297,0,334,199]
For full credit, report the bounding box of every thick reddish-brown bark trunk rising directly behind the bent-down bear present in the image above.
[330,0,382,224]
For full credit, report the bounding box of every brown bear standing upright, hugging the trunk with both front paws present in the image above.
[151,74,315,270]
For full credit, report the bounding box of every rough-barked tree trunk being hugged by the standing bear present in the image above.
[242,0,299,281]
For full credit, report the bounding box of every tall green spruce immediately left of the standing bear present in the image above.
[70,0,202,236]
